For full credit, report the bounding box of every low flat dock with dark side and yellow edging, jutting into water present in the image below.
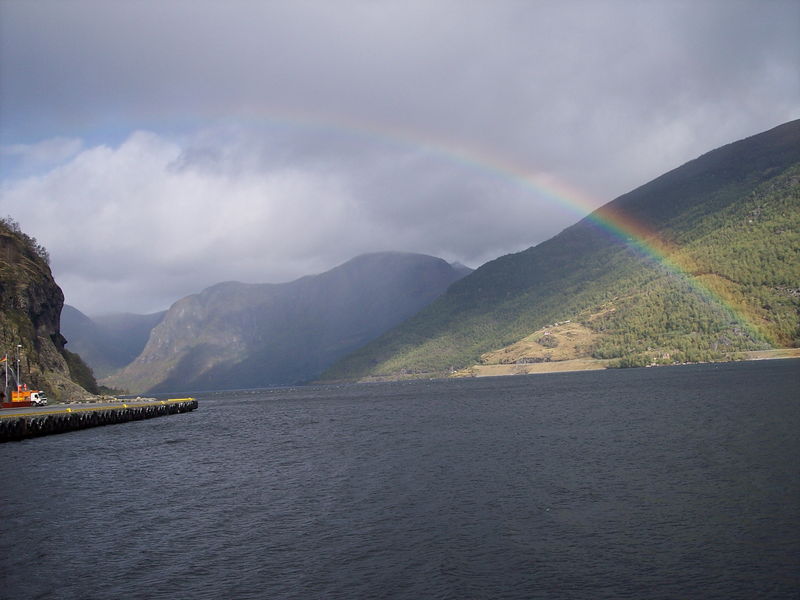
[0,398,197,443]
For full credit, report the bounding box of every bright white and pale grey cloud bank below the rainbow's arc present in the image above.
[2,130,574,314]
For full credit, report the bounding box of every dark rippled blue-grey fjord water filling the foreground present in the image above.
[0,360,800,599]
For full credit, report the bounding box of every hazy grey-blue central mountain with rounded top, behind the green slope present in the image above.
[104,252,468,392]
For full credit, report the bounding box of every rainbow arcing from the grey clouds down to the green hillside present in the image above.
[180,109,768,342]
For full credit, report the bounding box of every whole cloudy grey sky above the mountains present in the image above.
[0,0,800,316]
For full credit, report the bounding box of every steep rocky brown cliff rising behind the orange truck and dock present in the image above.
[0,219,97,401]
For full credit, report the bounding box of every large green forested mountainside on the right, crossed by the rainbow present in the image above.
[322,121,800,381]
